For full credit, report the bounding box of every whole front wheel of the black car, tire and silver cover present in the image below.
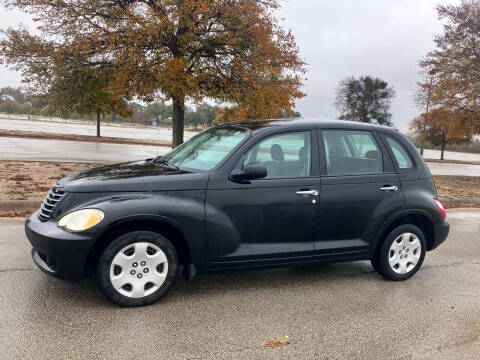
[97,231,179,307]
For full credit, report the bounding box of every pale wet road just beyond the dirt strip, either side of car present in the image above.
[0,137,480,176]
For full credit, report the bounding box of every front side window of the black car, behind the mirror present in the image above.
[243,131,311,179]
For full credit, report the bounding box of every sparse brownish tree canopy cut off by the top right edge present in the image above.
[419,0,480,134]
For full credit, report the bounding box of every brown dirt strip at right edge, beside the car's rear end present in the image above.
[433,175,480,199]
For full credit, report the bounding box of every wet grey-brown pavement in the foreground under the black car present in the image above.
[0,209,480,359]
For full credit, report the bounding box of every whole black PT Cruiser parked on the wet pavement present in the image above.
[25,120,449,306]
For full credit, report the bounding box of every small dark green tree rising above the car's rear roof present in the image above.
[335,76,395,126]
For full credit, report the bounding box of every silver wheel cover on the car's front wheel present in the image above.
[110,242,168,298]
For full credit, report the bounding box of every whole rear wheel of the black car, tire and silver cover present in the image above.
[371,224,426,281]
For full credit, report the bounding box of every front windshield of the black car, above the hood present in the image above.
[161,126,248,171]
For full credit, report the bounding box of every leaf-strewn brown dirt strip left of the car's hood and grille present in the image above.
[0,161,101,200]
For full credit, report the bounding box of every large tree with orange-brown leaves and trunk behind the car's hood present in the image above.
[0,0,305,147]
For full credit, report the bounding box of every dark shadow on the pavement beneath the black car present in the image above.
[27,261,380,307]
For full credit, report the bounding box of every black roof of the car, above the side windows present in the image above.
[221,118,396,132]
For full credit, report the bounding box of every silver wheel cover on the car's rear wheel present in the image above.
[388,233,422,274]
